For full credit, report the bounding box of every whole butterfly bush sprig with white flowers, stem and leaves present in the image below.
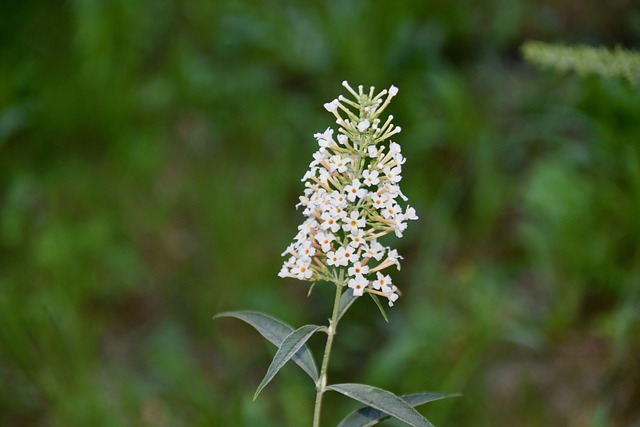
[215,82,450,427]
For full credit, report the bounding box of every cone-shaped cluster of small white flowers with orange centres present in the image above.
[279,82,418,306]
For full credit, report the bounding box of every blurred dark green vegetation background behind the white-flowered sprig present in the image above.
[0,0,640,427]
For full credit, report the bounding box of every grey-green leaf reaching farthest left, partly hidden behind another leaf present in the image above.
[213,311,319,384]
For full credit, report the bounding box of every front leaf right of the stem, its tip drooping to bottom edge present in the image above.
[327,384,433,427]
